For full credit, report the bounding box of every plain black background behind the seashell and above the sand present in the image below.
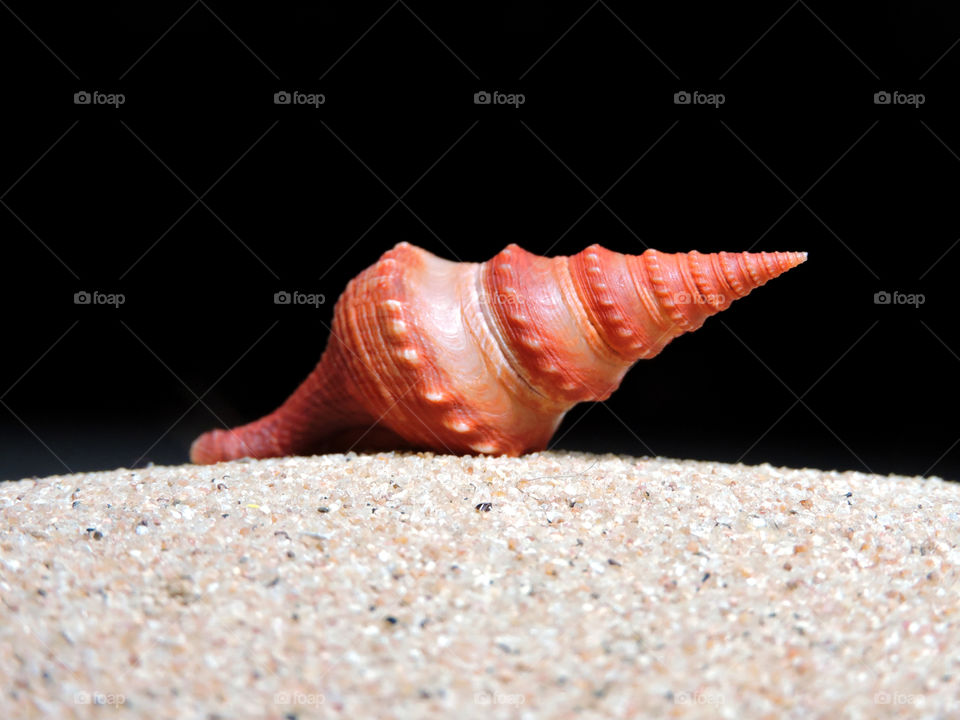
[0,0,960,479]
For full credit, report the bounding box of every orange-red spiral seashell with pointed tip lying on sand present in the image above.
[190,243,807,463]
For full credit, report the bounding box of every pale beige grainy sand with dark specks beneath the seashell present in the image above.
[0,453,960,720]
